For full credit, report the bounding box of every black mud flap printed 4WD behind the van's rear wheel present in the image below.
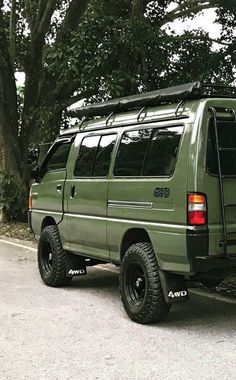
[159,269,189,304]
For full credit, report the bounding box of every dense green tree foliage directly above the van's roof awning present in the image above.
[45,0,234,108]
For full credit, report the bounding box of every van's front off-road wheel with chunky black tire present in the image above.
[38,226,72,287]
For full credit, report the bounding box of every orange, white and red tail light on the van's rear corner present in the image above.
[188,193,207,226]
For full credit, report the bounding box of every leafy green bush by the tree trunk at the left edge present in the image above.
[0,171,28,221]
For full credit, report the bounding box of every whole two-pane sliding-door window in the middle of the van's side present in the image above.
[74,134,116,177]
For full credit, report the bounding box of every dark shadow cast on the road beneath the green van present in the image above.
[64,268,236,332]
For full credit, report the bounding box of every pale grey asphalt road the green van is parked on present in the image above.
[0,241,236,380]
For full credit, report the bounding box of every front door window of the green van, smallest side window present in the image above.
[43,142,71,172]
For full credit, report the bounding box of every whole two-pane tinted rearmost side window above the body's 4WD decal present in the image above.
[114,126,183,177]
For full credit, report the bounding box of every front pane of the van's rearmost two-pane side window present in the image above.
[114,129,151,176]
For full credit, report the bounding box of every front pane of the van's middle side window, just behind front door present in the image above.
[74,136,100,177]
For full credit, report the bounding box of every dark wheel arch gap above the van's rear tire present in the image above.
[120,228,152,261]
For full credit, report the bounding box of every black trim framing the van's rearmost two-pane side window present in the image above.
[112,123,185,179]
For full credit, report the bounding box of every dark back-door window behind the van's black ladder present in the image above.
[206,121,236,176]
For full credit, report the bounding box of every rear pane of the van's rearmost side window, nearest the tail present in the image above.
[143,126,183,176]
